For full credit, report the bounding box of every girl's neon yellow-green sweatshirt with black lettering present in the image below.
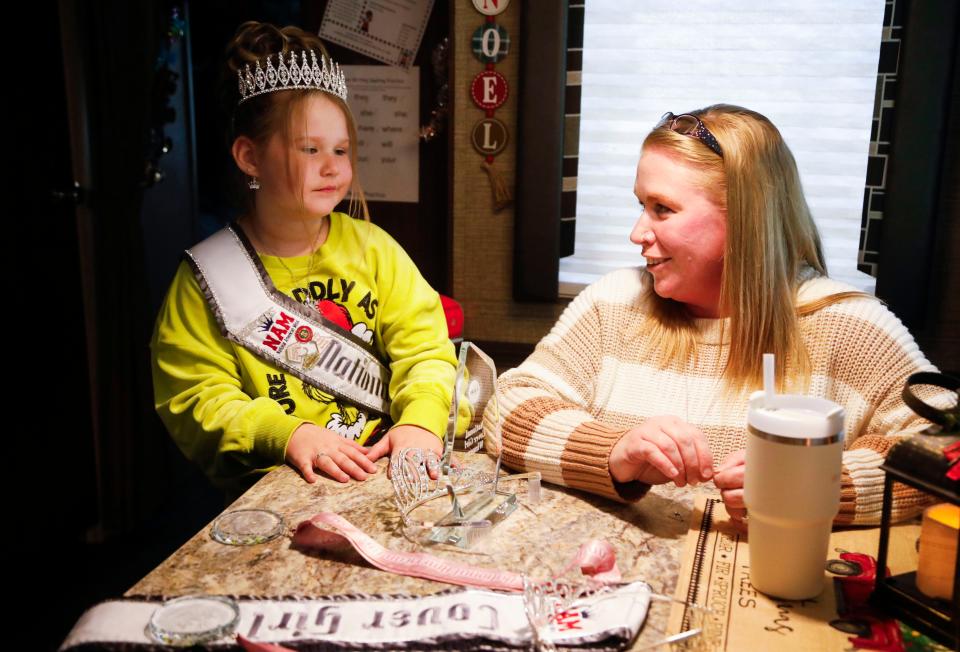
[150,213,456,495]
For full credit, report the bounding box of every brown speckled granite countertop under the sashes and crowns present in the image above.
[125,455,700,644]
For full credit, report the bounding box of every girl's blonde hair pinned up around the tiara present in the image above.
[220,21,370,222]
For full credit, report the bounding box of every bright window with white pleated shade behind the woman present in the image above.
[560,0,885,295]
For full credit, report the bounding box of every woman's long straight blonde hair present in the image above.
[643,104,827,389]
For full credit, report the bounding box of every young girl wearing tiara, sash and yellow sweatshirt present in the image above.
[151,22,456,496]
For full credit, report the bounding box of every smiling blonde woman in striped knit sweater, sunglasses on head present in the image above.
[500,105,934,523]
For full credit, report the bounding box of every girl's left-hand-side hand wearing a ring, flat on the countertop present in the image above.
[286,423,377,484]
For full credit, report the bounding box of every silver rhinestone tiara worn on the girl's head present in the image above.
[237,50,347,105]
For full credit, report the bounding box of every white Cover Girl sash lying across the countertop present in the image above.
[60,582,650,651]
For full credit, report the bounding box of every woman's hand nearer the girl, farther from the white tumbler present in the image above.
[610,416,713,487]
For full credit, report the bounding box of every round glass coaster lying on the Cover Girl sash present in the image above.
[147,595,240,647]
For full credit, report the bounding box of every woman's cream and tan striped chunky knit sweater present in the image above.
[488,268,946,524]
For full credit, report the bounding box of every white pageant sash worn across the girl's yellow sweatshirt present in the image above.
[187,227,390,416]
